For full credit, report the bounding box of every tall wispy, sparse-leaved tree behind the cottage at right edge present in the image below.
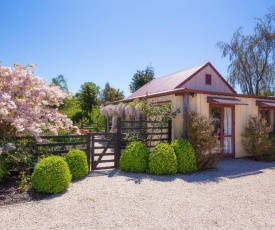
[217,8,275,95]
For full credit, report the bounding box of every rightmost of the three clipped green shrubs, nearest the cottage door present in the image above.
[171,139,197,173]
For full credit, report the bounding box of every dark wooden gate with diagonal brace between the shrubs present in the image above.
[90,132,121,170]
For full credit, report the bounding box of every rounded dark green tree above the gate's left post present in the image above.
[76,82,100,114]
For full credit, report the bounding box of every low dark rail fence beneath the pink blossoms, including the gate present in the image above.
[32,132,118,171]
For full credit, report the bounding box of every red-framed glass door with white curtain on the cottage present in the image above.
[211,105,235,158]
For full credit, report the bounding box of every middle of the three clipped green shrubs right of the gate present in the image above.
[149,143,178,175]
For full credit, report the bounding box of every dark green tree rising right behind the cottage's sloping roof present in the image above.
[129,66,155,93]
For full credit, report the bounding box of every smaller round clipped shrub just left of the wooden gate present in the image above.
[65,149,89,180]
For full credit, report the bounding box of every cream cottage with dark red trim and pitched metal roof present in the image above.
[123,62,275,158]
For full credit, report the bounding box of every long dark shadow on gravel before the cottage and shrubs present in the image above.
[88,158,275,184]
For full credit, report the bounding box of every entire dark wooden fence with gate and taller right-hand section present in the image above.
[10,119,171,171]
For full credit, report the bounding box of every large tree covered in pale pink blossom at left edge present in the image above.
[0,64,79,139]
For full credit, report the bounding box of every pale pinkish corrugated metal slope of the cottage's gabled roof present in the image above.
[126,63,207,99]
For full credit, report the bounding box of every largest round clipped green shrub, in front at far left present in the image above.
[32,156,72,194]
